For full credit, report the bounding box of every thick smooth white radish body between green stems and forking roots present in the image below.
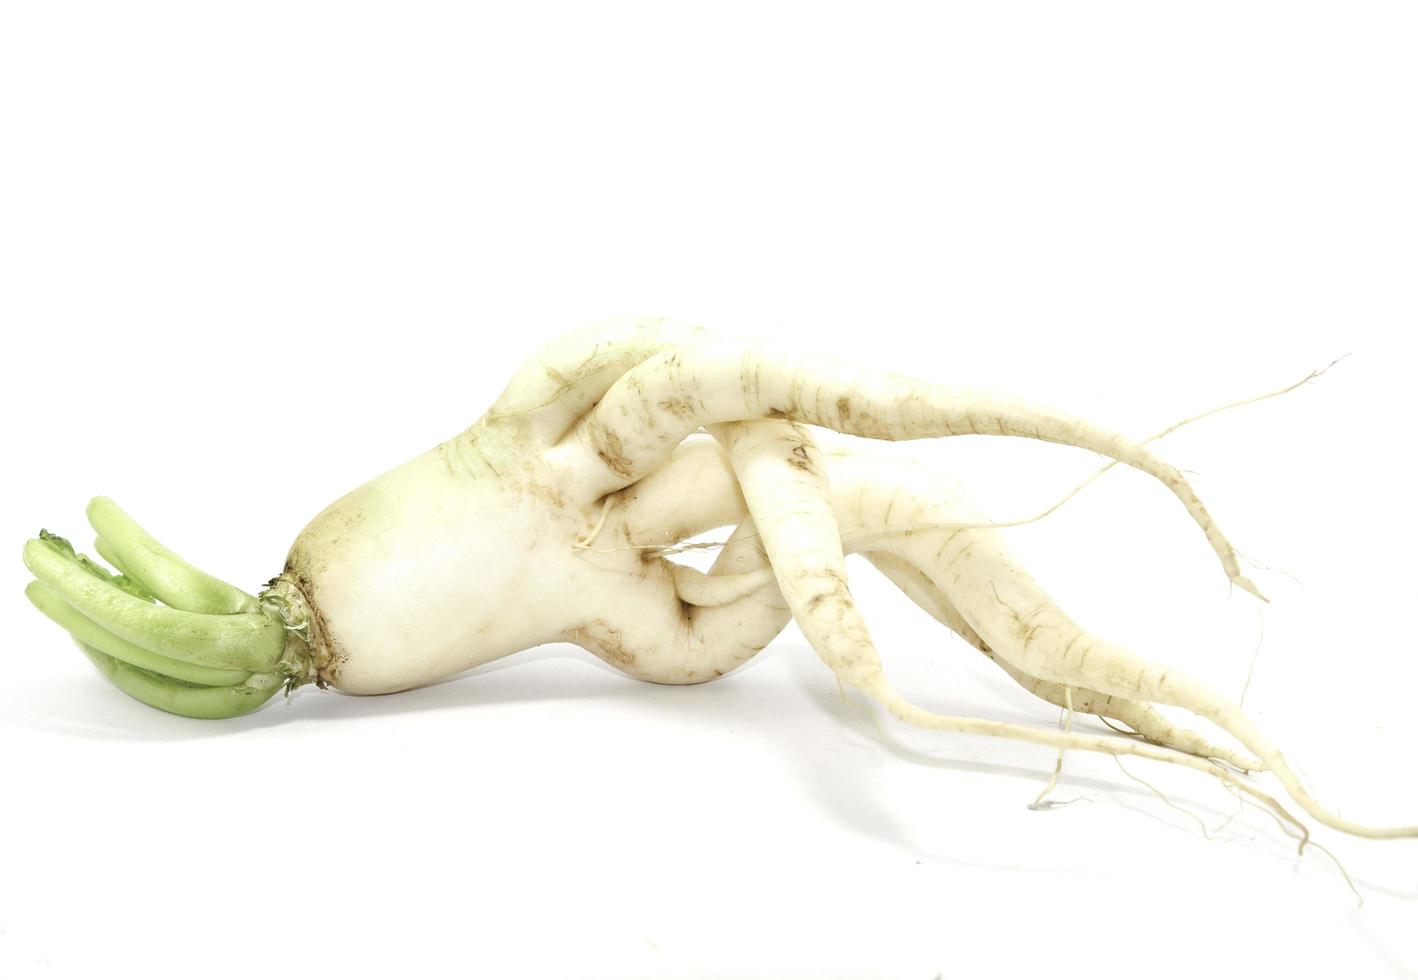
[282,427,587,694]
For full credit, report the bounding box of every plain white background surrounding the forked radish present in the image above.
[0,3,1418,980]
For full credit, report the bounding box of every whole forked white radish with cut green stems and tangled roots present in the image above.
[24,321,1418,837]
